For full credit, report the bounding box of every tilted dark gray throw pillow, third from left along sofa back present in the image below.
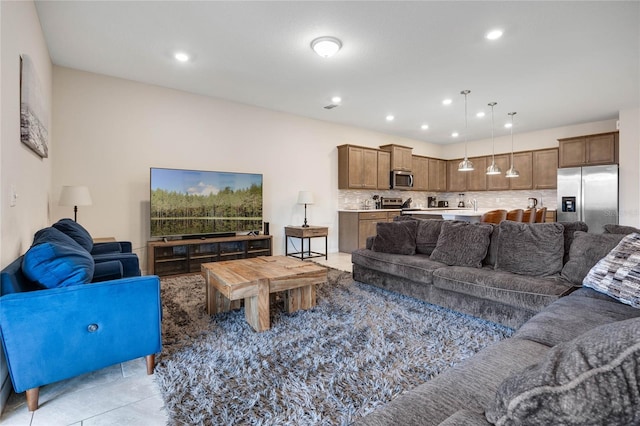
[430,220,493,268]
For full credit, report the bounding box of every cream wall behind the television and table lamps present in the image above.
[51,67,440,270]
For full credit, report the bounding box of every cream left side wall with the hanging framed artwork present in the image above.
[0,1,54,411]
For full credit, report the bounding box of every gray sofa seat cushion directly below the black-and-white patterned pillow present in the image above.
[514,287,640,346]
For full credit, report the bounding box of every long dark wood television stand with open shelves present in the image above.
[147,234,273,276]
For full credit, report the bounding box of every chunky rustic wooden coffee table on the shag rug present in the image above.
[201,256,327,331]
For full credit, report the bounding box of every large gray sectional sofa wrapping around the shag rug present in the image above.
[352,220,640,426]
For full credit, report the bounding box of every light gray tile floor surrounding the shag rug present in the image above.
[0,253,351,426]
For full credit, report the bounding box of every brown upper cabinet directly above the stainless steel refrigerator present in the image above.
[558,132,619,167]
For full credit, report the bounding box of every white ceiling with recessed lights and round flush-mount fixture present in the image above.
[36,1,640,144]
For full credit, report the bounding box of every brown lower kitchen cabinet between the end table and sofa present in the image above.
[338,210,400,253]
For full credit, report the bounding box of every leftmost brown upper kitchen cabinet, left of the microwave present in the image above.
[338,145,378,189]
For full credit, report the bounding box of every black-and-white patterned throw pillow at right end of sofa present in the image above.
[582,233,640,308]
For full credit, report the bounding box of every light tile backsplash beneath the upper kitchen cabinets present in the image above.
[338,189,557,210]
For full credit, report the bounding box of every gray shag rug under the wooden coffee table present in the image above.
[155,269,513,425]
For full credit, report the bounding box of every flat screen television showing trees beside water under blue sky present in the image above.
[149,167,262,238]
